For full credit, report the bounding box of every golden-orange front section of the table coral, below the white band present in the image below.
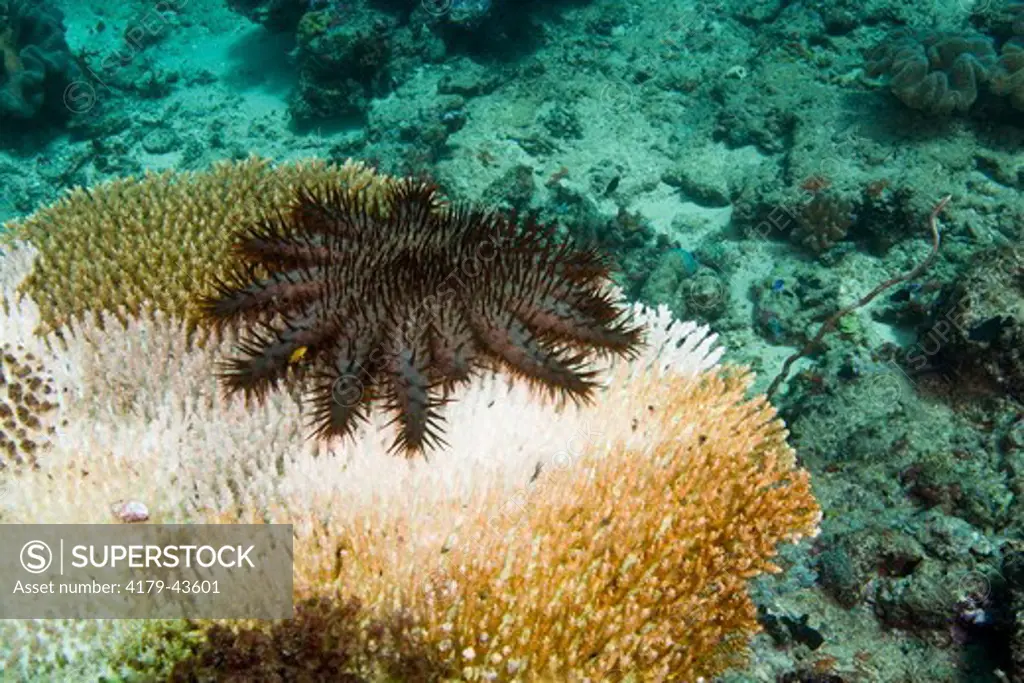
[167,352,820,683]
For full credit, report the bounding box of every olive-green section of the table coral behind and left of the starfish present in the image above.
[0,158,390,330]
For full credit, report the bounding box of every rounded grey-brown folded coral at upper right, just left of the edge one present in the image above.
[866,30,996,116]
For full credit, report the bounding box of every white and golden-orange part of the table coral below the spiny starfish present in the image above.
[0,244,820,681]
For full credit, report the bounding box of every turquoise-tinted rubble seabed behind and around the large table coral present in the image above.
[0,0,1024,682]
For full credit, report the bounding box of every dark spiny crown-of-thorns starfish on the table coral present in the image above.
[203,180,640,453]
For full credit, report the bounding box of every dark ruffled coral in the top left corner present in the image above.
[0,0,78,127]
